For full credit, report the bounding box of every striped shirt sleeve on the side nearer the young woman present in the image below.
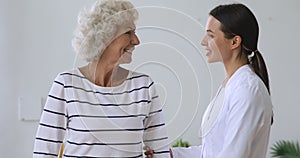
[143,79,170,158]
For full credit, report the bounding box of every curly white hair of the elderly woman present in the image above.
[72,0,138,62]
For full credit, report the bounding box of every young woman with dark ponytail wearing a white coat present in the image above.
[147,4,272,158]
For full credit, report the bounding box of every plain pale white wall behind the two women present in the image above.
[0,0,300,158]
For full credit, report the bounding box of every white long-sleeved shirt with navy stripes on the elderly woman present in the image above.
[33,68,169,158]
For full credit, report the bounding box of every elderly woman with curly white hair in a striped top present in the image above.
[33,0,169,158]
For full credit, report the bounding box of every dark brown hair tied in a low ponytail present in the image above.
[209,3,270,94]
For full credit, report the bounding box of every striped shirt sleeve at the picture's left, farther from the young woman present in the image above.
[33,75,67,158]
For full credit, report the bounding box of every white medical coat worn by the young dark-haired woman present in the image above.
[172,65,272,158]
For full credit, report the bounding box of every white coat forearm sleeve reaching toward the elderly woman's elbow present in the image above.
[171,146,202,158]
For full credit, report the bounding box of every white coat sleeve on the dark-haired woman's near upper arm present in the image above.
[217,86,265,158]
